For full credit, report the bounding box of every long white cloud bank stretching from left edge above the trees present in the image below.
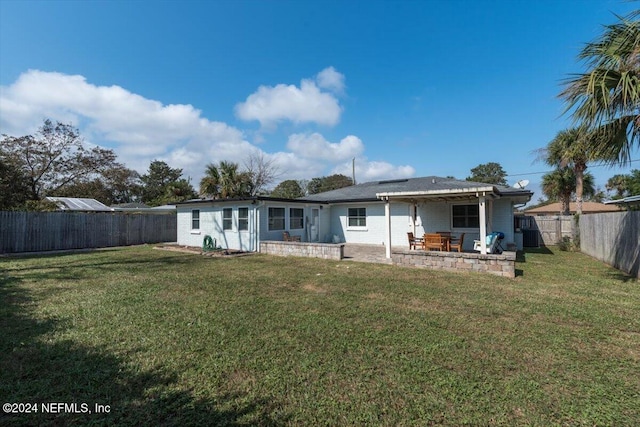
[0,70,248,181]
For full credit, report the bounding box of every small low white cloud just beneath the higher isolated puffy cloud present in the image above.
[287,133,364,162]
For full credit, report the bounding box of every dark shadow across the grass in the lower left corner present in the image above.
[0,272,286,426]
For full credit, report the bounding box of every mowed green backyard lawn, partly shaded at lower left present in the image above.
[0,247,640,426]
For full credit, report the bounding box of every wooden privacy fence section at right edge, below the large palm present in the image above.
[580,211,640,277]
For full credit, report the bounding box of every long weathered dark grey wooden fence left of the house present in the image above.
[0,212,177,253]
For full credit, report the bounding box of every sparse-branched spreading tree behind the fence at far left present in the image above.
[0,119,118,200]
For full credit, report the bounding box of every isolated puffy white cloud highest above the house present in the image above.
[235,69,343,128]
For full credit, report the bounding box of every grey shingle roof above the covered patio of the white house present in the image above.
[303,176,532,202]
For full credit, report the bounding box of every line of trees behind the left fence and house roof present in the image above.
[0,119,352,210]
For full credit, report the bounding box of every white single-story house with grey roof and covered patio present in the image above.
[177,176,533,258]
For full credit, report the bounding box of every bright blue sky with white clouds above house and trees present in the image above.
[0,0,640,203]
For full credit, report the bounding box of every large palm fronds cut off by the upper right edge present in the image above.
[560,10,640,164]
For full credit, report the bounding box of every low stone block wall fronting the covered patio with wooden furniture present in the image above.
[391,250,516,277]
